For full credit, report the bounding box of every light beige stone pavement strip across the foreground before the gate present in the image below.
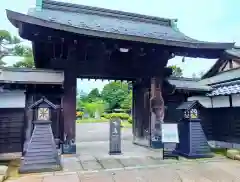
[7,159,240,182]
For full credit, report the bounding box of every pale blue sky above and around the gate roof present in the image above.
[0,0,240,92]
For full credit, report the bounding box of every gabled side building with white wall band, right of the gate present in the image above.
[199,48,240,148]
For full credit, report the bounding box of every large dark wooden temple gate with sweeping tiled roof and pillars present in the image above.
[7,0,234,153]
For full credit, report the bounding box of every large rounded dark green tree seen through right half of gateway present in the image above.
[101,81,129,111]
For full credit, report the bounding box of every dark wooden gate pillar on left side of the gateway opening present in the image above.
[63,47,77,154]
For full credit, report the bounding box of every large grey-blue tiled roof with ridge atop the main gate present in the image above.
[7,0,234,51]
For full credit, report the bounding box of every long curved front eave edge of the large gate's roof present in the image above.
[6,10,234,50]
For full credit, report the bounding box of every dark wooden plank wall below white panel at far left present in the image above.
[0,108,25,153]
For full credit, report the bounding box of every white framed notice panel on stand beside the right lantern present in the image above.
[162,123,179,143]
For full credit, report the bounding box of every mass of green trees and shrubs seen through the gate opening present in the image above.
[77,81,132,117]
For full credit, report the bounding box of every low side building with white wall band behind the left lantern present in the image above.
[0,68,64,160]
